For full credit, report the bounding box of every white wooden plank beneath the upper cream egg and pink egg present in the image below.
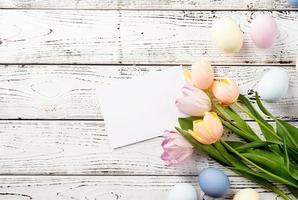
[0,10,298,65]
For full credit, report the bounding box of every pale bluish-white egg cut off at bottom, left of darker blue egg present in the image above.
[168,183,198,200]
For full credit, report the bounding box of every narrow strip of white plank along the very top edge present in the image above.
[0,0,295,10]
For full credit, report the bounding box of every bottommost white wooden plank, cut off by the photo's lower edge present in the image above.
[0,176,279,200]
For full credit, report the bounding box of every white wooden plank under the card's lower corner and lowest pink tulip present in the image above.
[0,120,298,176]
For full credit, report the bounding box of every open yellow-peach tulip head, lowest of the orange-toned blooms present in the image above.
[190,112,224,144]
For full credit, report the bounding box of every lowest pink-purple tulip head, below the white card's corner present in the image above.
[161,131,193,166]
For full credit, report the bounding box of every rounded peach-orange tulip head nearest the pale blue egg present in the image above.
[212,79,239,106]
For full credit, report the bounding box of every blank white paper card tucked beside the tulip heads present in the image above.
[98,67,184,148]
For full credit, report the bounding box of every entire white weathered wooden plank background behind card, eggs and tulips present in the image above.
[0,0,298,200]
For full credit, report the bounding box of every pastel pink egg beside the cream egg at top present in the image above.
[250,14,278,49]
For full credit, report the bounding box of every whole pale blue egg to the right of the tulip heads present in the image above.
[257,68,289,102]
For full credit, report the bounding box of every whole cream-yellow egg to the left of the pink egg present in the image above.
[212,18,243,53]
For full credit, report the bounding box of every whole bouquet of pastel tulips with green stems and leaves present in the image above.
[161,61,298,200]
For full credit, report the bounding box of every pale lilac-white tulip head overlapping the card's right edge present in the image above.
[176,85,211,116]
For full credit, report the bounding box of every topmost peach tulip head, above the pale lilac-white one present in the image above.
[191,60,214,90]
